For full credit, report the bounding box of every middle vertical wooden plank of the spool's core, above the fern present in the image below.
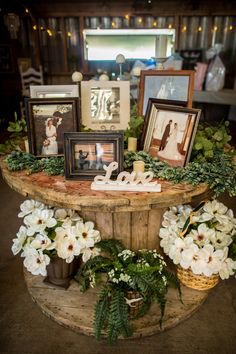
[113,212,132,248]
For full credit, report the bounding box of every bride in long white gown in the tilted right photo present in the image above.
[157,123,183,160]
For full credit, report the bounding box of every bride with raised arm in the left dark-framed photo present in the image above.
[42,118,62,155]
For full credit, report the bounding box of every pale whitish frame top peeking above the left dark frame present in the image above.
[30,85,79,98]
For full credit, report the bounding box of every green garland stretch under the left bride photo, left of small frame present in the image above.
[5,151,64,175]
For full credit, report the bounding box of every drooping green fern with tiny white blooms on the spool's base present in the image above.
[75,240,179,343]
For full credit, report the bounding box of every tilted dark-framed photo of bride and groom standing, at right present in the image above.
[141,99,201,167]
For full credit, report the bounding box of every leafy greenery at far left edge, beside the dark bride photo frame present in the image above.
[0,113,27,155]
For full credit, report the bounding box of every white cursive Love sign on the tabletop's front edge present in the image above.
[91,161,161,192]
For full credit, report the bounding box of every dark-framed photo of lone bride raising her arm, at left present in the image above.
[26,98,79,157]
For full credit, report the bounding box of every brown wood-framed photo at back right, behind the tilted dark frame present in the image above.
[138,70,194,115]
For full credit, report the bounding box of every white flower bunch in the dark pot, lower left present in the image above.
[12,200,101,276]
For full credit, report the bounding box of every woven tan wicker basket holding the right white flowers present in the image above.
[177,267,220,290]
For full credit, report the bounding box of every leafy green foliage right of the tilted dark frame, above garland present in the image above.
[191,121,235,162]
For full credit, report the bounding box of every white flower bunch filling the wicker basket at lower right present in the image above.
[160,200,236,279]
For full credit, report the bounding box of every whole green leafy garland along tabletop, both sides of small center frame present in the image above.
[5,150,236,197]
